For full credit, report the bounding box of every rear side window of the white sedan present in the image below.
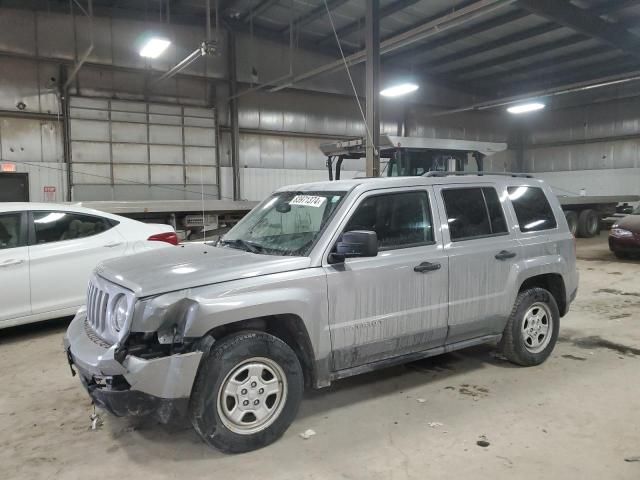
[33,211,114,244]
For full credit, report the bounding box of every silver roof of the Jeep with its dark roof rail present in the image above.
[277,174,544,192]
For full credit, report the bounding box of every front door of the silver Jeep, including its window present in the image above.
[324,187,448,370]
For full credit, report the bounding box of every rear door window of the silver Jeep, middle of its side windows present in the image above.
[442,187,508,242]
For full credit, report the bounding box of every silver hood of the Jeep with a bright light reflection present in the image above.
[96,244,311,298]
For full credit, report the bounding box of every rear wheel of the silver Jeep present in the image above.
[499,288,560,367]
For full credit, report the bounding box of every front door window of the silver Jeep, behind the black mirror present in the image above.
[345,192,433,250]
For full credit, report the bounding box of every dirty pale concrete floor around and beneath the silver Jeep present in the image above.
[0,234,640,480]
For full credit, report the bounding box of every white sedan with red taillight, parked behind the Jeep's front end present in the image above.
[0,202,178,328]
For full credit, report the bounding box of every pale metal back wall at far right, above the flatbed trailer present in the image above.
[524,97,640,195]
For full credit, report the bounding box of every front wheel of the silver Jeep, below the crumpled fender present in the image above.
[189,331,304,453]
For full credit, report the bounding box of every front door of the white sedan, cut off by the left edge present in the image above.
[0,212,31,322]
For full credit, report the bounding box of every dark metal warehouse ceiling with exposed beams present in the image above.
[12,0,640,107]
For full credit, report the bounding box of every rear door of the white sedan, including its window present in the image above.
[29,210,126,314]
